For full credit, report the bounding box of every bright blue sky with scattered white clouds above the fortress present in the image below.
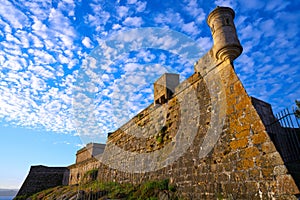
[0,0,300,188]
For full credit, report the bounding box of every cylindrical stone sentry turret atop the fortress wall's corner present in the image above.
[207,7,243,61]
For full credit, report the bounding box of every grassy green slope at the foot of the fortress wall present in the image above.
[22,179,178,200]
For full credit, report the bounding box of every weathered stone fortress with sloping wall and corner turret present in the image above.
[18,7,299,199]
